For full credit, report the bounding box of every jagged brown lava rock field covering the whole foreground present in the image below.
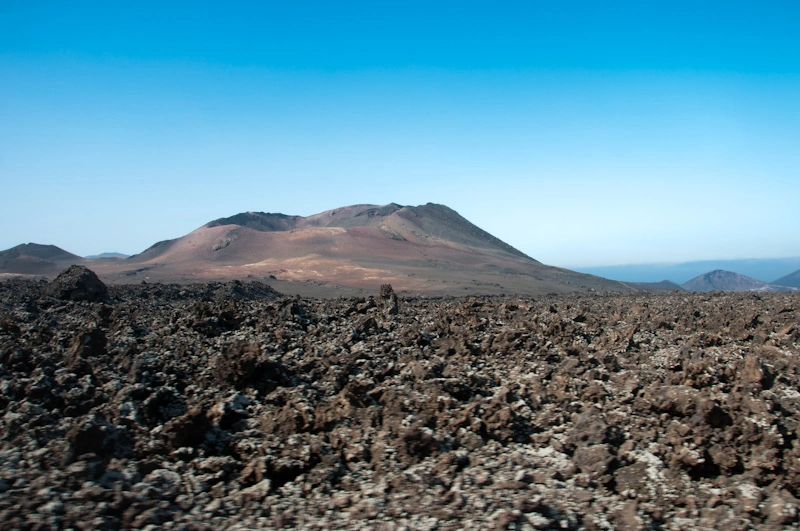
[0,271,800,530]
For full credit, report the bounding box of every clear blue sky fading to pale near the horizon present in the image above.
[0,0,800,267]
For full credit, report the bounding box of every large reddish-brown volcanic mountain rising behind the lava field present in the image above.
[97,203,630,295]
